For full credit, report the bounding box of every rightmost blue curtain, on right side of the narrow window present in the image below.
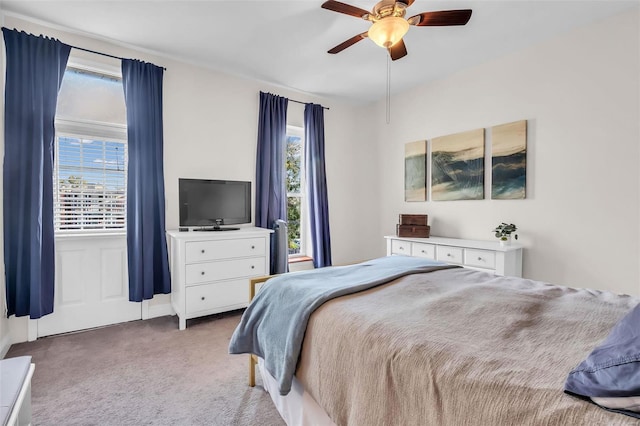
[304,104,331,268]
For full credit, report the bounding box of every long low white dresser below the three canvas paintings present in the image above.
[385,236,522,277]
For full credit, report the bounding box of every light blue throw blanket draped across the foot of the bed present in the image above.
[229,256,455,395]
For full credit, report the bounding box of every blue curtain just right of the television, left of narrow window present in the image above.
[256,92,289,274]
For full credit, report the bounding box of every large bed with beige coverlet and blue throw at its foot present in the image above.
[230,256,639,426]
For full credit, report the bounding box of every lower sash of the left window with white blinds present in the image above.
[53,134,127,231]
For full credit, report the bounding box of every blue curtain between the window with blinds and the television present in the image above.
[122,59,171,302]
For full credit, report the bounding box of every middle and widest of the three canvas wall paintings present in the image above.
[431,129,484,201]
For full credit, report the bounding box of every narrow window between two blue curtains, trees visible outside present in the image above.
[286,126,307,257]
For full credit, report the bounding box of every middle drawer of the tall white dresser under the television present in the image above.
[185,257,267,286]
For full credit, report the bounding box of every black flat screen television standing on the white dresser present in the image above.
[178,178,251,231]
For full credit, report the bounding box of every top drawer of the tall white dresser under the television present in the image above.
[185,238,266,263]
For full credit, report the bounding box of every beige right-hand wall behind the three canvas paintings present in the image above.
[369,11,640,295]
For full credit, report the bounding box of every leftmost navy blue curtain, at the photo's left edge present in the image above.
[2,28,71,319]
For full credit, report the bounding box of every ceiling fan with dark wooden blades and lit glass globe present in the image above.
[322,0,471,61]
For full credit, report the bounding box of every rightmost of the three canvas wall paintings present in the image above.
[491,120,527,200]
